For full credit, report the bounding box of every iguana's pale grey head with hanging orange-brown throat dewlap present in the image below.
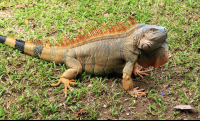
[137,25,169,68]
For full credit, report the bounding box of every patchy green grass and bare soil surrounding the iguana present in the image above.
[0,0,200,120]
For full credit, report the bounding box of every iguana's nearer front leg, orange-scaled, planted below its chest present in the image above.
[122,62,147,97]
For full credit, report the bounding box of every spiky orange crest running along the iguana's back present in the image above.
[34,17,137,47]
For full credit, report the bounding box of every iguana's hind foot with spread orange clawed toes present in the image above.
[51,78,77,98]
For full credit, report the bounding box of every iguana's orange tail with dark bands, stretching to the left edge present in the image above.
[0,35,68,64]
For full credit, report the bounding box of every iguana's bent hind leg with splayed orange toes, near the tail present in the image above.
[51,57,82,97]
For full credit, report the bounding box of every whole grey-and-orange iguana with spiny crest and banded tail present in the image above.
[0,18,168,97]
